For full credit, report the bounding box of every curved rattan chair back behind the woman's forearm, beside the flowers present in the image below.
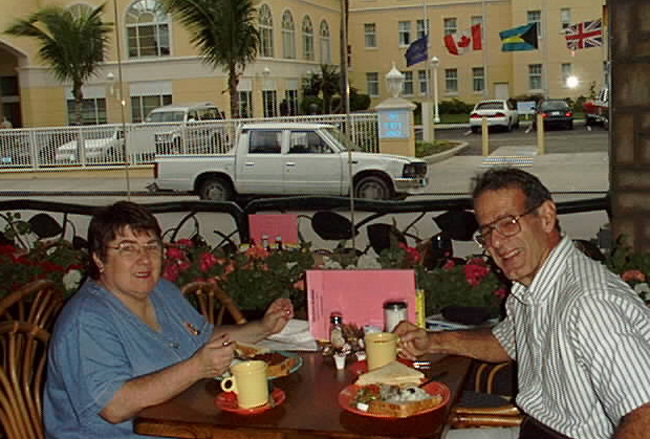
[181,282,246,325]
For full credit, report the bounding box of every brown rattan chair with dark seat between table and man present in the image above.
[449,362,524,428]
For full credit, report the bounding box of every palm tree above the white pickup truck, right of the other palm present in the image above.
[162,0,260,117]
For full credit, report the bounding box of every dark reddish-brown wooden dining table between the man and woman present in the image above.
[134,352,471,439]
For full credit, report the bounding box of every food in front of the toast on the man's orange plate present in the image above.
[350,384,442,418]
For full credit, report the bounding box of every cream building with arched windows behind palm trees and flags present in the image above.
[0,0,606,127]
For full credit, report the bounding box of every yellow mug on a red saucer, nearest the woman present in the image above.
[221,360,269,409]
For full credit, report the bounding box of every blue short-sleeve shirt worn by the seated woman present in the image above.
[43,280,213,439]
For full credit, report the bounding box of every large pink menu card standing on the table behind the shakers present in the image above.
[307,270,415,340]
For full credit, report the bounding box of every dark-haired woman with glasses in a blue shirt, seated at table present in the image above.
[43,201,293,439]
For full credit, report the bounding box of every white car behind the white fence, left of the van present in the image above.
[54,129,124,164]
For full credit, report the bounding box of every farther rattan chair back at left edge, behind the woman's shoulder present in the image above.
[0,279,63,332]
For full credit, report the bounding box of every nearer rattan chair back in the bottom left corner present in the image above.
[0,321,50,439]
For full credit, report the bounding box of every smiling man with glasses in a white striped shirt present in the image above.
[395,168,650,439]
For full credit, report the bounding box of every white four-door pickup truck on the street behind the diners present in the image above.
[151,123,427,201]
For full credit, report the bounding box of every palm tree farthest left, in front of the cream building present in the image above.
[5,4,113,125]
